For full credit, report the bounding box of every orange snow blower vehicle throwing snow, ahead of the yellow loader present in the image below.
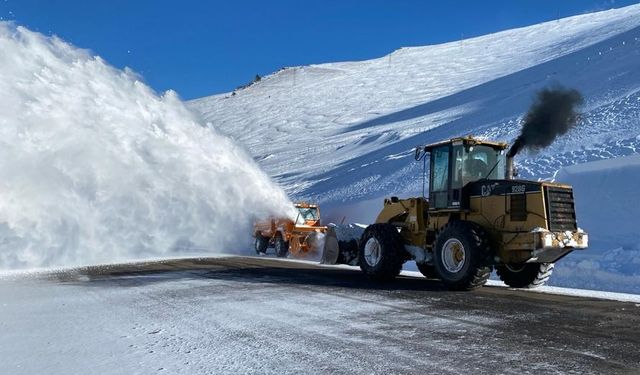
[253,202,338,263]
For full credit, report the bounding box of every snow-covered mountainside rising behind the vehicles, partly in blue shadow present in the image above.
[189,4,640,292]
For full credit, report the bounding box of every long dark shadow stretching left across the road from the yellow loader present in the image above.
[45,257,456,291]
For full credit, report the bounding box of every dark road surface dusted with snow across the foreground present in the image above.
[0,257,640,374]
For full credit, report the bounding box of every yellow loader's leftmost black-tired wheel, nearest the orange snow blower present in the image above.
[358,223,405,281]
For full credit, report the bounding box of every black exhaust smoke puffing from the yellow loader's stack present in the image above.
[507,87,583,158]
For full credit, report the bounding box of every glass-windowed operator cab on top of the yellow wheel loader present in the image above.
[425,137,507,209]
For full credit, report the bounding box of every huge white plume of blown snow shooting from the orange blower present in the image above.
[0,22,294,269]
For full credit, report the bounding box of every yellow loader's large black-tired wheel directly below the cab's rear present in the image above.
[434,221,491,290]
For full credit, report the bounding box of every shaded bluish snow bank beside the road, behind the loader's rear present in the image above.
[550,154,640,293]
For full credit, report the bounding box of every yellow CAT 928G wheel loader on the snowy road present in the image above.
[358,136,588,290]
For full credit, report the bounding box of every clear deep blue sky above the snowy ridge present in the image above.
[0,0,638,99]
